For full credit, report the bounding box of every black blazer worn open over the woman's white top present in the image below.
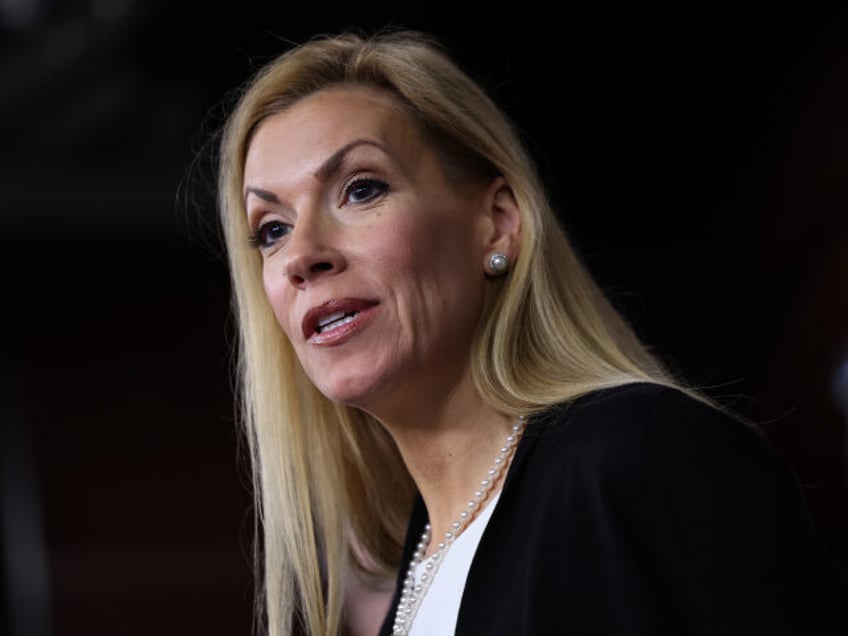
[380,383,848,636]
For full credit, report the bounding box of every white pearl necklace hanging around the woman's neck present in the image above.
[392,415,526,636]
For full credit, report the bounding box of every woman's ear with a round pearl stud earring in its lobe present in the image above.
[483,176,521,276]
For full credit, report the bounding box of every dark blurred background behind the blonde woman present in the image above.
[0,0,848,636]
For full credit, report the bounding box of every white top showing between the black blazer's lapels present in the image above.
[409,490,500,636]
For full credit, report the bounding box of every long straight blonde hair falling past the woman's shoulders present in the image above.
[219,31,675,635]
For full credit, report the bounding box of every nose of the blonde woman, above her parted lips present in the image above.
[284,212,345,289]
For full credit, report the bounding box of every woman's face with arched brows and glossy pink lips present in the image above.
[244,87,496,416]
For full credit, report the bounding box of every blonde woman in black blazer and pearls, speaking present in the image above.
[214,31,846,635]
